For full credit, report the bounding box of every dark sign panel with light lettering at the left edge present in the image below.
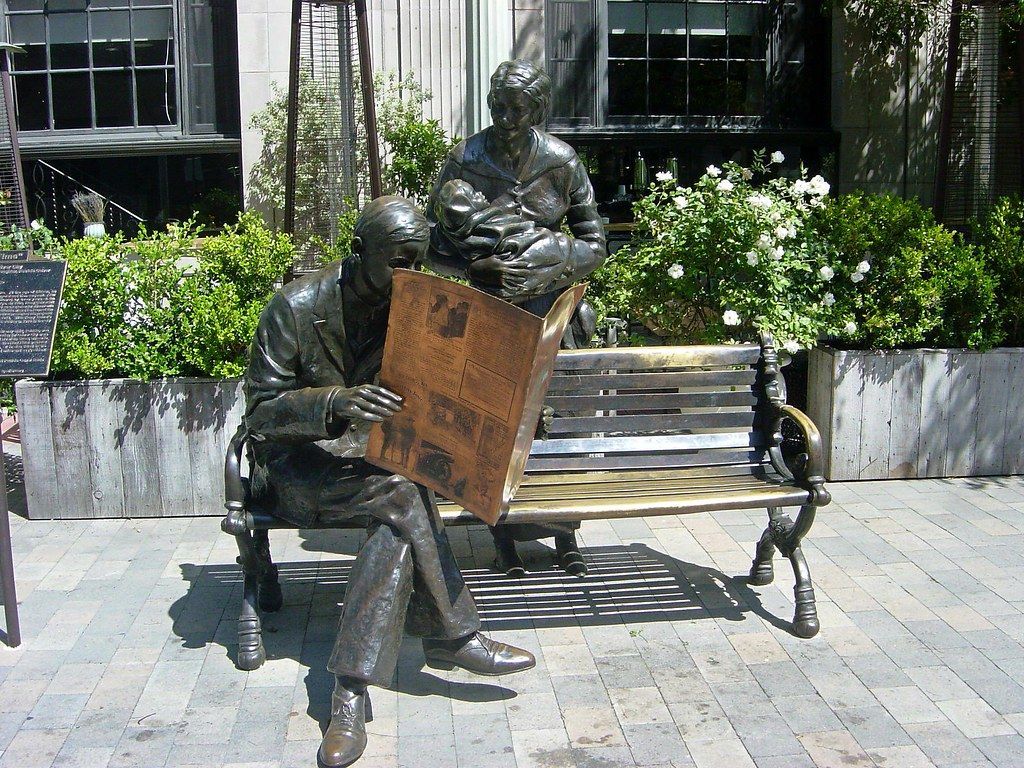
[0,261,68,378]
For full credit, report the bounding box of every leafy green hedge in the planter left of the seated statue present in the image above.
[51,213,293,379]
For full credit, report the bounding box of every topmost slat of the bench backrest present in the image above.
[555,344,761,371]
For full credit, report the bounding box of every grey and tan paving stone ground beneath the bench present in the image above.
[0,444,1024,768]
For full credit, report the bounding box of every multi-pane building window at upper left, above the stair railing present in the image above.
[6,0,238,133]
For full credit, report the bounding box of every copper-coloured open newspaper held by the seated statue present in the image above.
[367,269,586,525]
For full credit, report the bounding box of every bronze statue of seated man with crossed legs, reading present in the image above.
[245,197,536,768]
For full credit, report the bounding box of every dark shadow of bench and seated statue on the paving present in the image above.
[169,544,774,728]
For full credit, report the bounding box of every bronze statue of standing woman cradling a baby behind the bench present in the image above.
[427,59,607,575]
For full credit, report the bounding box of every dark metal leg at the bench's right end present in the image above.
[749,505,819,638]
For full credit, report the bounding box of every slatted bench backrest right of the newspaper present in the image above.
[526,344,774,473]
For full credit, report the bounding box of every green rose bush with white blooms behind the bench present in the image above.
[590,154,849,351]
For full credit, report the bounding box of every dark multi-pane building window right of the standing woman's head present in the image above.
[547,0,828,128]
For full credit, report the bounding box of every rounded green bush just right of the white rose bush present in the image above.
[814,193,1000,348]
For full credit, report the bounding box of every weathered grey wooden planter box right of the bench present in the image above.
[807,347,1024,480]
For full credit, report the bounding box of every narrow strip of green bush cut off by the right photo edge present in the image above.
[974,197,1024,346]
